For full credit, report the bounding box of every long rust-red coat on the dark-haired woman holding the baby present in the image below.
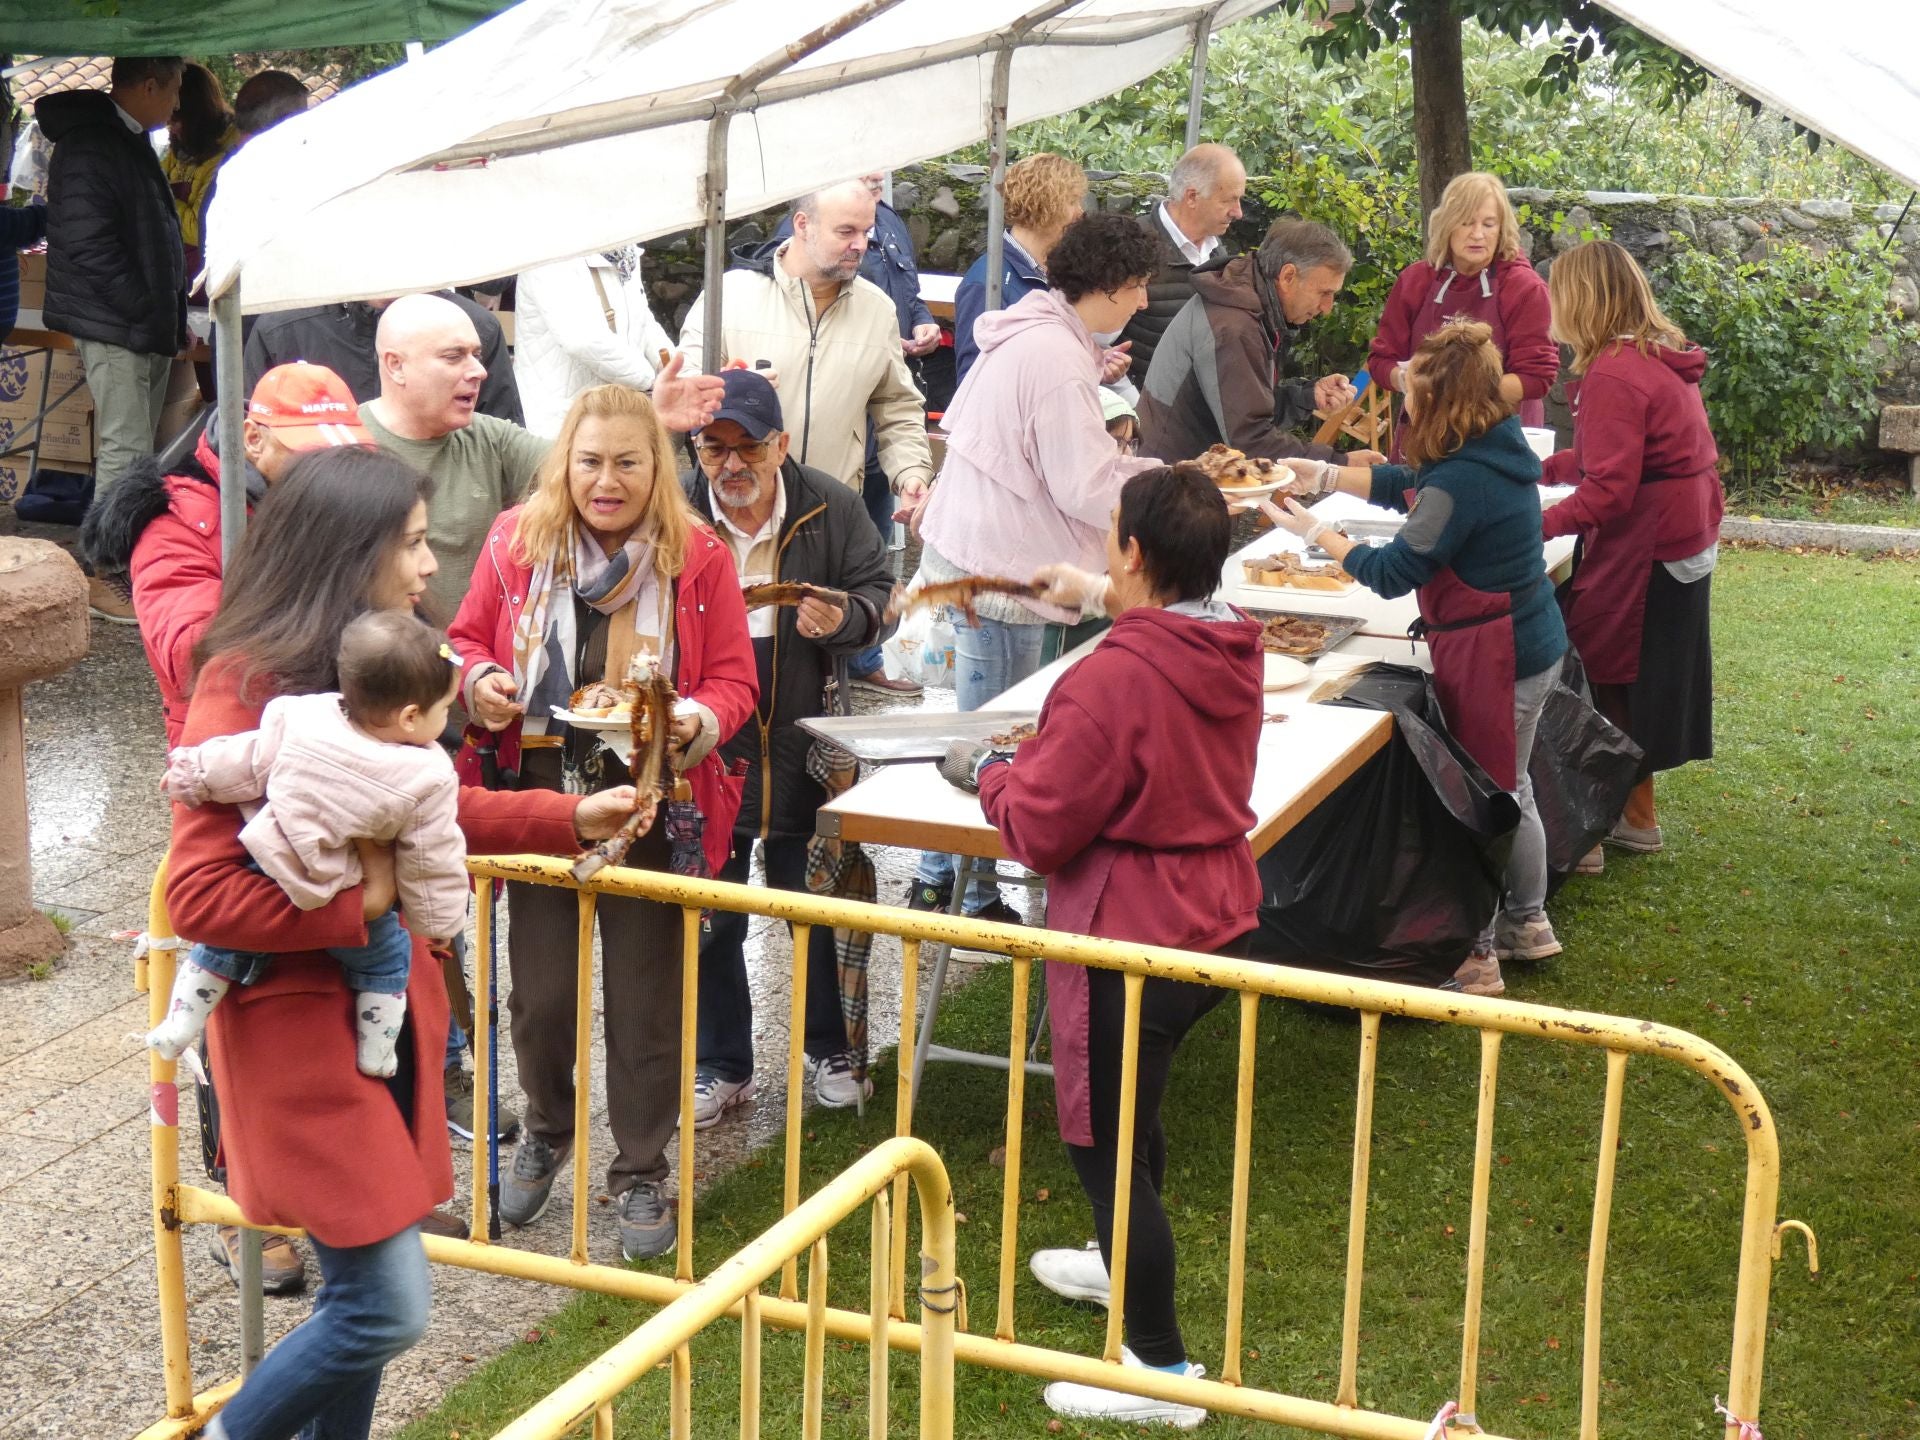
[167,666,580,1246]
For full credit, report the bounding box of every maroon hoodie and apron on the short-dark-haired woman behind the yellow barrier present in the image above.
[979,609,1265,1144]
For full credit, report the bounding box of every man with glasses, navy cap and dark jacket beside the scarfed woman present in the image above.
[687,371,893,1129]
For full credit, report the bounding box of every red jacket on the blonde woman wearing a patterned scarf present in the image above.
[447,505,760,876]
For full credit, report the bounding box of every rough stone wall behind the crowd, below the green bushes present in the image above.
[647,165,1920,403]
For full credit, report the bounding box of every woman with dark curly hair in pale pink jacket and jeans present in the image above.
[910,215,1158,920]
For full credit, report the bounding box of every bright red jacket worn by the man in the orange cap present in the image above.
[127,436,221,749]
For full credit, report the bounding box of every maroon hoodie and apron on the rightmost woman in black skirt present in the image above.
[1540,344,1724,685]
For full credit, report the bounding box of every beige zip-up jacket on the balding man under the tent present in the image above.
[680,242,933,490]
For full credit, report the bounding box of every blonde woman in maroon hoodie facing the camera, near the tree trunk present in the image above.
[1367,171,1559,443]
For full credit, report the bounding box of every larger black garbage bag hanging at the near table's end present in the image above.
[1252,664,1519,985]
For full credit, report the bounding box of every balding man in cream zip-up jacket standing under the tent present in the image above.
[680,180,933,518]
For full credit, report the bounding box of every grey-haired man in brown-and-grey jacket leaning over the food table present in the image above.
[1140,219,1384,465]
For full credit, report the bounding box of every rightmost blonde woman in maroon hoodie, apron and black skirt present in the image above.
[1542,240,1724,874]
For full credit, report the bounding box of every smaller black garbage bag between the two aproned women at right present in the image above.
[1526,649,1642,895]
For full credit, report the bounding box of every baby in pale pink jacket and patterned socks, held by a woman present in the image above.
[146,611,467,1075]
